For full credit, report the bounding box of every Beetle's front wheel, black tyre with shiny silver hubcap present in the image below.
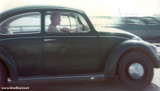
[117,52,154,89]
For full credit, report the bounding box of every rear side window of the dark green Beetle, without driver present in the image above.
[0,12,41,35]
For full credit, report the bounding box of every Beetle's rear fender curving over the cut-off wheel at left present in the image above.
[0,48,18,81]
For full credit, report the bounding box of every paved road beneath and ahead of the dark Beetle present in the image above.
[9,69,160,91]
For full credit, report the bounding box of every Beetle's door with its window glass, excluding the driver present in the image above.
[44,11,99,75]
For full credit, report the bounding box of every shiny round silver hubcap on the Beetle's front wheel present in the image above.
[128,63,144,80]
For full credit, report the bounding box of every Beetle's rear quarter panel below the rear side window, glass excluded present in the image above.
[1,36,43,76]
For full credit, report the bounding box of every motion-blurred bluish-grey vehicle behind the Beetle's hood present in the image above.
[106,17,160,43]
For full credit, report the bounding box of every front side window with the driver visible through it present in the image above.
[45,11,90,34]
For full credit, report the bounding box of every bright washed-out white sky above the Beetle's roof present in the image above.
[0,0,160,16]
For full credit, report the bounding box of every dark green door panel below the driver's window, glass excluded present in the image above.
[44,34,99,75]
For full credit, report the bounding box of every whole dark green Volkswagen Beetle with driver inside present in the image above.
[0,6,160,89]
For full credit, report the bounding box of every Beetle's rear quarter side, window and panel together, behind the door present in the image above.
[0,12,43,77]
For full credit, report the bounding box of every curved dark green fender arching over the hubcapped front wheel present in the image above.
[104,40,160,78]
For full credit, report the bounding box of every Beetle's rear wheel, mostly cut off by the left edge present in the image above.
[0,63,7,89]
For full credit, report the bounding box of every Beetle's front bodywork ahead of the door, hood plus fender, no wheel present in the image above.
[96,28,160,78]
